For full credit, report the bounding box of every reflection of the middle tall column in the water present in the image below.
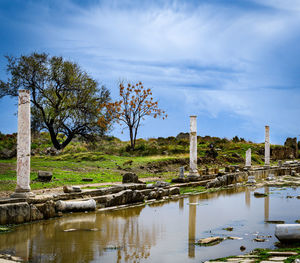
[188,195,197,258]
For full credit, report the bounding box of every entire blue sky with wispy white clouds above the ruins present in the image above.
[0,0,300,144]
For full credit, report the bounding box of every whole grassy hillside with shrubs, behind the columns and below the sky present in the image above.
[0,133,296,193]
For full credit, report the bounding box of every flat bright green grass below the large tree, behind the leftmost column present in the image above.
[0,155,189,191]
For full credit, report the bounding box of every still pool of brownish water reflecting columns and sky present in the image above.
[0,187,300,263]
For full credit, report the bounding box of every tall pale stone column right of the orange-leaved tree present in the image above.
[188,116,199,177]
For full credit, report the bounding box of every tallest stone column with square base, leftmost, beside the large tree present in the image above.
[11,90,33,198]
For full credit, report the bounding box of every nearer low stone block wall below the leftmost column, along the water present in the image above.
[0,184,180,225]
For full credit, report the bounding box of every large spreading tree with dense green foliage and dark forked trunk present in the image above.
[0,53,110,149]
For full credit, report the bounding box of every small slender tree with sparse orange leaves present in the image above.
[105,82,168,150]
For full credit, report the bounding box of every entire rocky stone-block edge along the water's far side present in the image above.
[0,161,300,225]
